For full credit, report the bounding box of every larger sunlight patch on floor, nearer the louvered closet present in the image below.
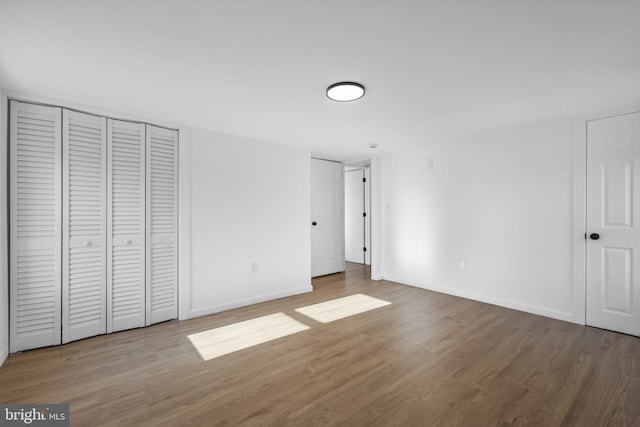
[188,313,309,361]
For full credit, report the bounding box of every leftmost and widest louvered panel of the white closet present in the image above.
[9,101,62,352]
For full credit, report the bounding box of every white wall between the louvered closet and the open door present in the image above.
[189,129,312,316]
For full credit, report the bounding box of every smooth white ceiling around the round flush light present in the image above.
[0,0,640,161]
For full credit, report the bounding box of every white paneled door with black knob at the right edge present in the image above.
[587,113,640,336]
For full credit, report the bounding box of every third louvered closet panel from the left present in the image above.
[107,120,146,332]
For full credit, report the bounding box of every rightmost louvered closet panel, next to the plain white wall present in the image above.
[147,125,178,324]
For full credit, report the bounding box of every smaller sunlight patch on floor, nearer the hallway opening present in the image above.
[296,294,391,323]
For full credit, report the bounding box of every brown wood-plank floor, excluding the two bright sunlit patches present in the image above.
[0,264,640,426]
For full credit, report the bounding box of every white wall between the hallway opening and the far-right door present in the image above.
[381,121,582,322]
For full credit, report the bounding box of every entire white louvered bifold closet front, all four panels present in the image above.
[9,101,178,352]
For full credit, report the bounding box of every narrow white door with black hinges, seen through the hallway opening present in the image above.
[344,169,367,264]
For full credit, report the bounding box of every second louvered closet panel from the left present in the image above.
[62,110,107,343]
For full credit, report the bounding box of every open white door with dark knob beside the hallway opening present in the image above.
[311,159,344,277]
